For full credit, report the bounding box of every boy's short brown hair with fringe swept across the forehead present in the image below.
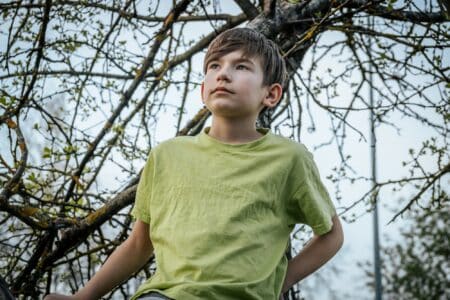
[203,28,286,86]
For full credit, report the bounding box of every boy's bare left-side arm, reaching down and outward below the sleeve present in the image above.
[44,220,153,300]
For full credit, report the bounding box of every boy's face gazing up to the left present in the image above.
[202,51,278,119]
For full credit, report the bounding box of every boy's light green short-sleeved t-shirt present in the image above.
[132,128,335,300]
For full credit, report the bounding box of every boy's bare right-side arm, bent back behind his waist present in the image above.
[282,215,344,293]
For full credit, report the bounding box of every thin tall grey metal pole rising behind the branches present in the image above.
[368,17,382,300]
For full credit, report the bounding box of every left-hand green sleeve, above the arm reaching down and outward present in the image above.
[131,153,155,224]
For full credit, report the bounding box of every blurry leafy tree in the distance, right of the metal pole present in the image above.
[365,194,450,299]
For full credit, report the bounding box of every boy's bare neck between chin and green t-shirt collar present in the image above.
[208,117,262,144]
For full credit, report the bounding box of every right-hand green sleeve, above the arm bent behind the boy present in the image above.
[288,148,336,235]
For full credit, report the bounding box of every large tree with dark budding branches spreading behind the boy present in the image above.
[0,0,450,298]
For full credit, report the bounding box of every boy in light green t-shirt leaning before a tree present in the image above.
[46,28,343,300]
